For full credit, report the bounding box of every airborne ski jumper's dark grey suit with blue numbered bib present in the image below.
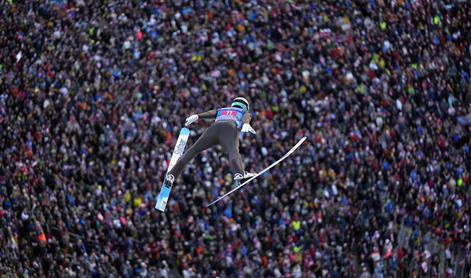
[168,107,251,180]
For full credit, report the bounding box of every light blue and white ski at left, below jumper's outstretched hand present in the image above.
[155,127,190,211]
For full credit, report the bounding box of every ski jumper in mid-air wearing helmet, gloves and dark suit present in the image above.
[166,97,256,184]
